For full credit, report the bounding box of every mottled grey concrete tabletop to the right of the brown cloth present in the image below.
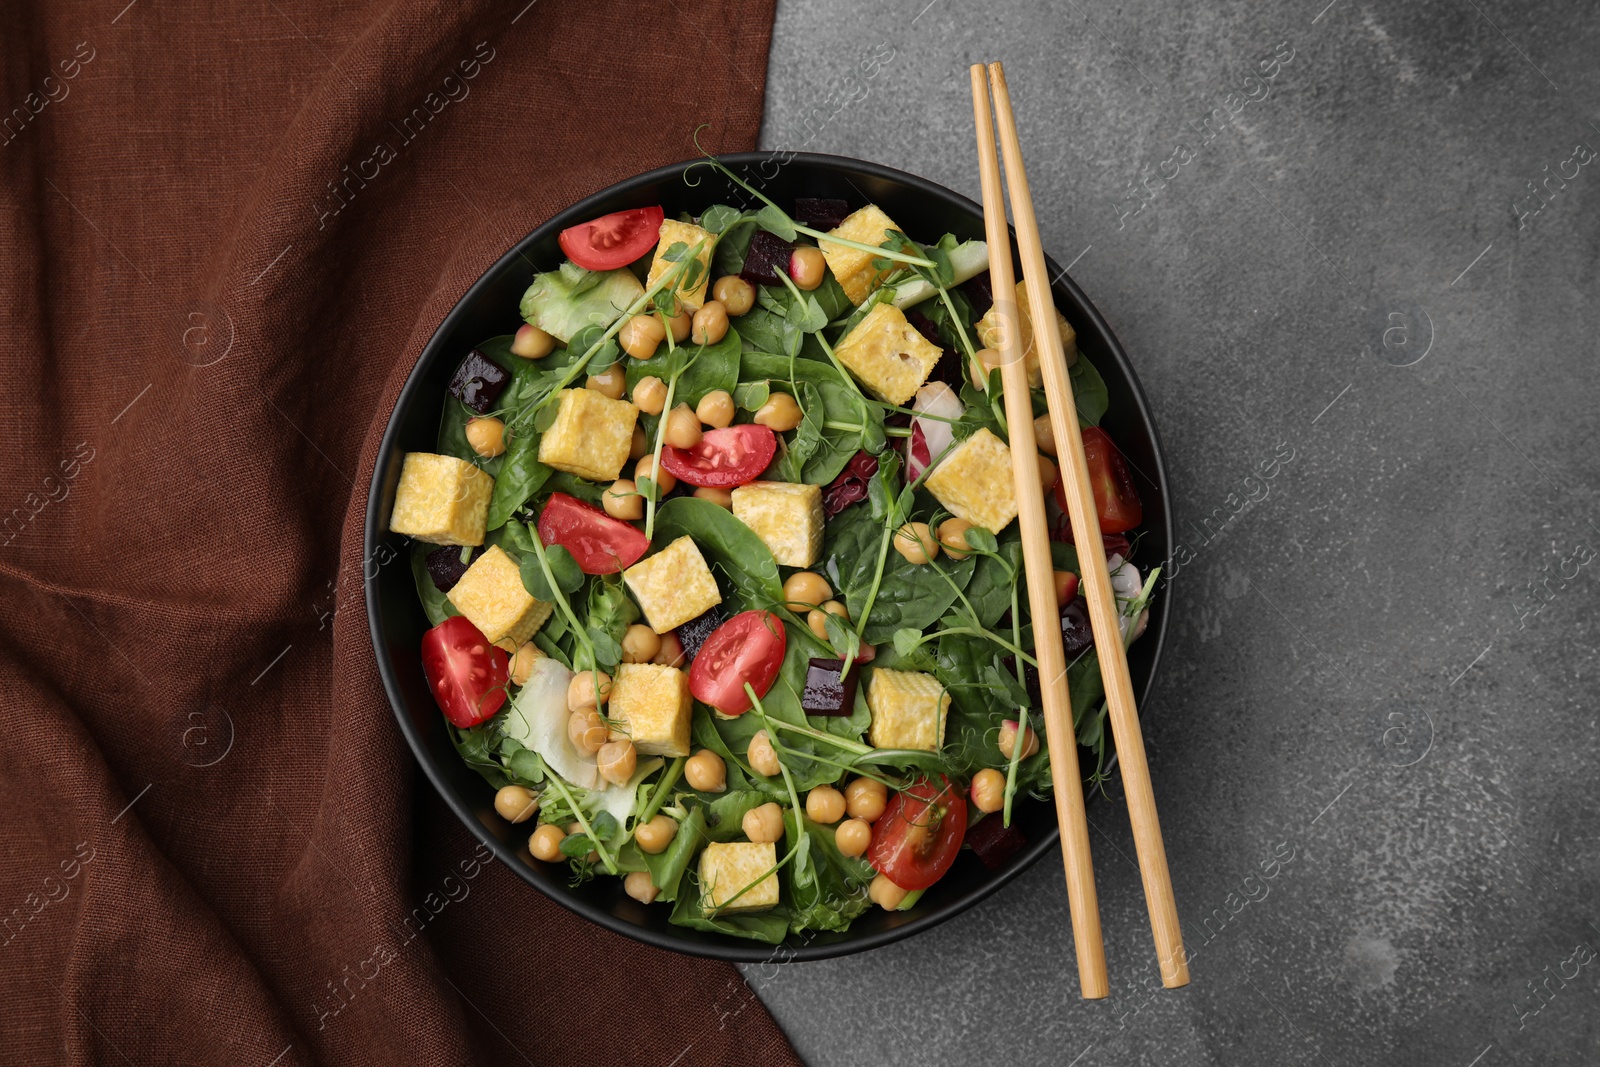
[749,0,1600,1067]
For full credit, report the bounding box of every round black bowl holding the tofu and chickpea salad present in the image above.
[365,152,1173,961]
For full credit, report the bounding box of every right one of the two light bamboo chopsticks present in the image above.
[973,62,1189,989]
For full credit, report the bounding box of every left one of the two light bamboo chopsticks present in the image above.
[971,64,1110,1000]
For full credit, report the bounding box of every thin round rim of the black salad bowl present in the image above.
[363,150,1174,963]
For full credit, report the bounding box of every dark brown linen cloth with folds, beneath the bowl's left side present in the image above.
[0,0,797,1067]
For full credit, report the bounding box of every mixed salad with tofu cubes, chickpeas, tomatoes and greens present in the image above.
[387,158,1155,944]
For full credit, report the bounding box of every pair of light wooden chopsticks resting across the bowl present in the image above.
[971,62,1189,1000]
